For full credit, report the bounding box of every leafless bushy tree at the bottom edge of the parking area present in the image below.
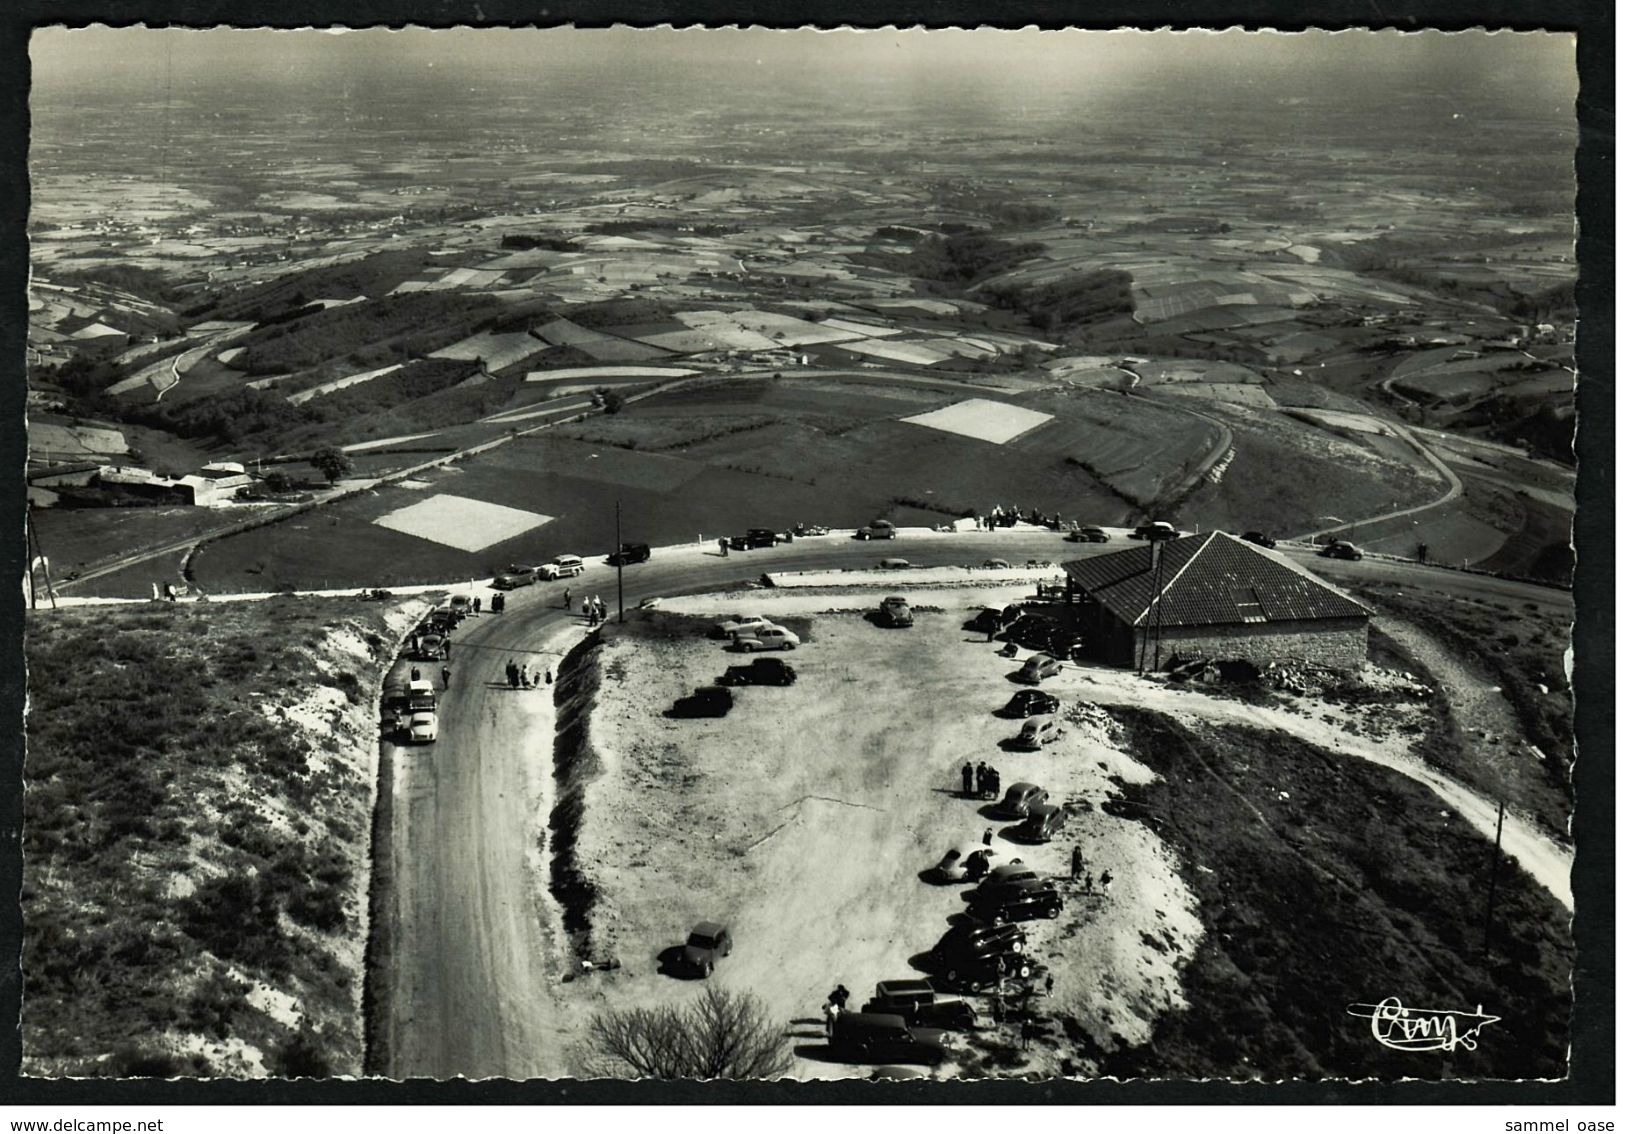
[577,985,791,1079]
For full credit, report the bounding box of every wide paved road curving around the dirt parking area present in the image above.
[374,531,1570,1079]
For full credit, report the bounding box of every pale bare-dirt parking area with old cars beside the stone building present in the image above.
[559,585,1201,1077]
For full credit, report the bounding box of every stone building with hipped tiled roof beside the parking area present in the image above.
[1064,531,1372,669]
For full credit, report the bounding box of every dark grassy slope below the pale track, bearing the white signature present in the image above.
[1103,708,1573,1079]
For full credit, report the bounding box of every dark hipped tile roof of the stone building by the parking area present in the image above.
[1064,531,1372,627]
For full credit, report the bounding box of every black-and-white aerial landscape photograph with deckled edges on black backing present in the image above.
[15,15,1612,1100]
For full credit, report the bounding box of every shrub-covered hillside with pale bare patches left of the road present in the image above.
[23,596,410,1077]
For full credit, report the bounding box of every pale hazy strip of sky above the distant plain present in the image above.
[31,26,1576,99]
